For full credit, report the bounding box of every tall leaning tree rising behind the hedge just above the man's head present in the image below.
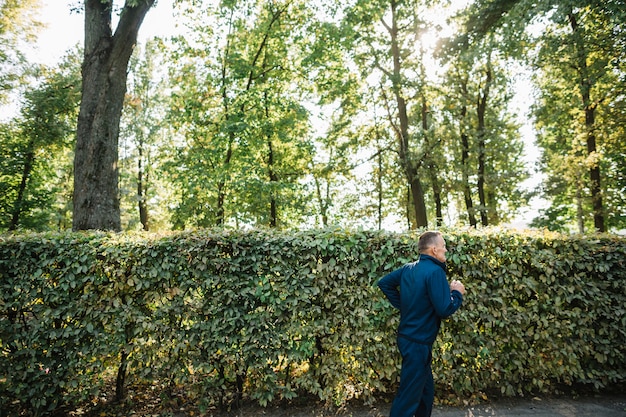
[346,0,428,227]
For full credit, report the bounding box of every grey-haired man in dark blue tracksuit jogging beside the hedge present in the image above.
[378,232,465,417]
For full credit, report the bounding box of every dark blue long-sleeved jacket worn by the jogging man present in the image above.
[378,254,463,345]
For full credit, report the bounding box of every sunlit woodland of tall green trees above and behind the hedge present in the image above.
[0,0,626,232]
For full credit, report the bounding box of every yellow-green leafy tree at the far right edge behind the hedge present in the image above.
[536,2,625,233]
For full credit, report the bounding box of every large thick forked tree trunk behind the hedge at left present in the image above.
[73,0,155,231]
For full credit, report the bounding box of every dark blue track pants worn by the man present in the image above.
[389,337,435,417]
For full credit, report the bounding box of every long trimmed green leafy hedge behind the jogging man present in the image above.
[0,230,626,415]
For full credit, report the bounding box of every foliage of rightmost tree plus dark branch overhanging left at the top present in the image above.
[461,0,626,233]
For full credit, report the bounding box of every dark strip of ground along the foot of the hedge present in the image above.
[64,387,626,417]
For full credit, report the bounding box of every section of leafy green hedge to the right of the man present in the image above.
[436,234,626,396]
